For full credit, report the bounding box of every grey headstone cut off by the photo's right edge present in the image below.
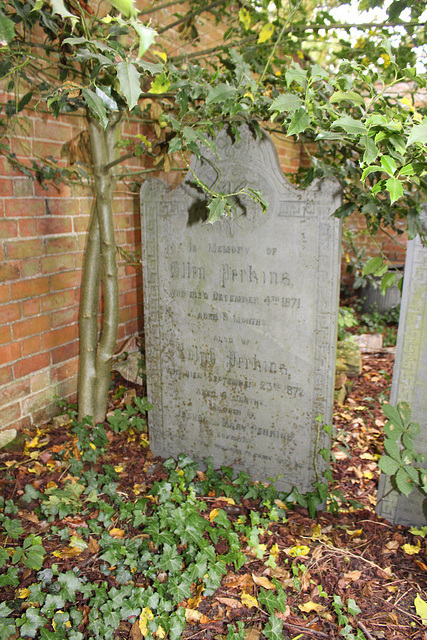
[377,214,427,526]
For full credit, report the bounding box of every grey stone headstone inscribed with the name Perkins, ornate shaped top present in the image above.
[141,127,340,491]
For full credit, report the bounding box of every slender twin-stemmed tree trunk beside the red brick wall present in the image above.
[78,119,119,424]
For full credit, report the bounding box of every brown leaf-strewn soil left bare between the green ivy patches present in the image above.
[0,352,427,640]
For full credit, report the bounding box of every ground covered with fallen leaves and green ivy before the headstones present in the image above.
[0,353,427,640]
